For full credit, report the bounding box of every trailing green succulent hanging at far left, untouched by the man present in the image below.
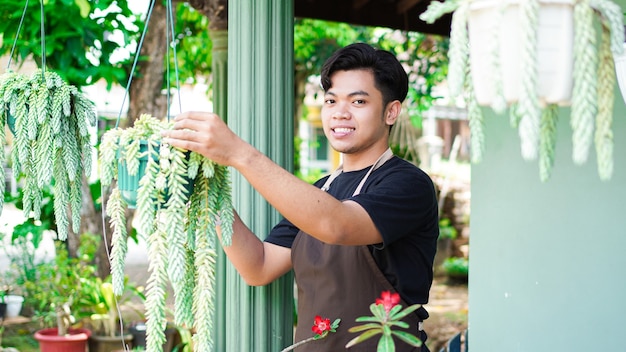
[0,70,96,240]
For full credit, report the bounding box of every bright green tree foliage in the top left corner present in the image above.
[0,0,141,87]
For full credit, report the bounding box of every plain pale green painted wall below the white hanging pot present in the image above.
[469,70,626,352]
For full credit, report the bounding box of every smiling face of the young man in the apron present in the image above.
[322,70,389,154]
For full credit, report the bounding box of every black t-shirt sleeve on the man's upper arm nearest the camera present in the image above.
[350,169,438,245]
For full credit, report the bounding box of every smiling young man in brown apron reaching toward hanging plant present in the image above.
[165,43,439,351]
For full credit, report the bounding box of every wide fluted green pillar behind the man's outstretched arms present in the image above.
[216,0,294,352]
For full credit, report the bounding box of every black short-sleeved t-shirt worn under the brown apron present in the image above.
[265,157,439,304]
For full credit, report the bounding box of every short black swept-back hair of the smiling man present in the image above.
[321,43,409,106]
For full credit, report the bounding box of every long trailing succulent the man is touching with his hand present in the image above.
[100,114,234,351]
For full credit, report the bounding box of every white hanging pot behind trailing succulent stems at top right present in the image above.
[468,0,574,106]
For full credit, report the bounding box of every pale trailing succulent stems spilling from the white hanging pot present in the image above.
[420,0,624,181]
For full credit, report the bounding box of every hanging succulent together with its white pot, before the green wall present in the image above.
[420,0,624,181]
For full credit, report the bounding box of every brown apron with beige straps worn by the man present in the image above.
[291,150,421,352]
